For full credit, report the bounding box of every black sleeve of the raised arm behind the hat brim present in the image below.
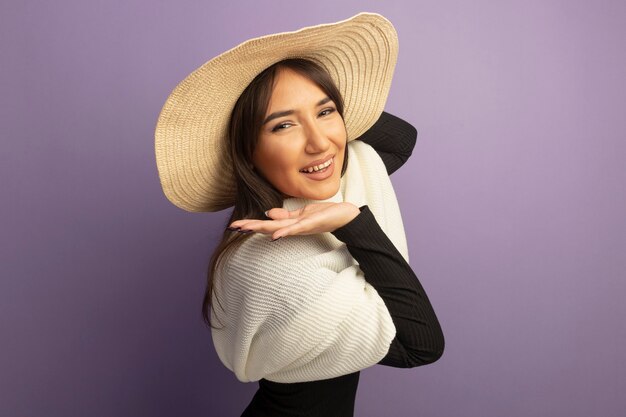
[356,112,417,175]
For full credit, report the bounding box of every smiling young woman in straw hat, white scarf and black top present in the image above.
[156,13,444,416]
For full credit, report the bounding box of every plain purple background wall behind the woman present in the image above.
[0,0,626,417]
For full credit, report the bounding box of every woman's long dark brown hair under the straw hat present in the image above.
[202,58,348,328]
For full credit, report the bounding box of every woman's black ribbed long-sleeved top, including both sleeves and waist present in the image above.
[241,112,444,417]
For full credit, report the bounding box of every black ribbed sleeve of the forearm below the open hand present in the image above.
[331,205,444,368]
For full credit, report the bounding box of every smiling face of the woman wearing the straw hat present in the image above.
[252,68,347,200]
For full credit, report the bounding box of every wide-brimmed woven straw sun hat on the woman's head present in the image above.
[155,13,398,212]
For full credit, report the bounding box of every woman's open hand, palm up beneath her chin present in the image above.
[230,202,360,240]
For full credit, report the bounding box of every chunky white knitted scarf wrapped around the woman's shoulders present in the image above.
[211,140,409,382]
